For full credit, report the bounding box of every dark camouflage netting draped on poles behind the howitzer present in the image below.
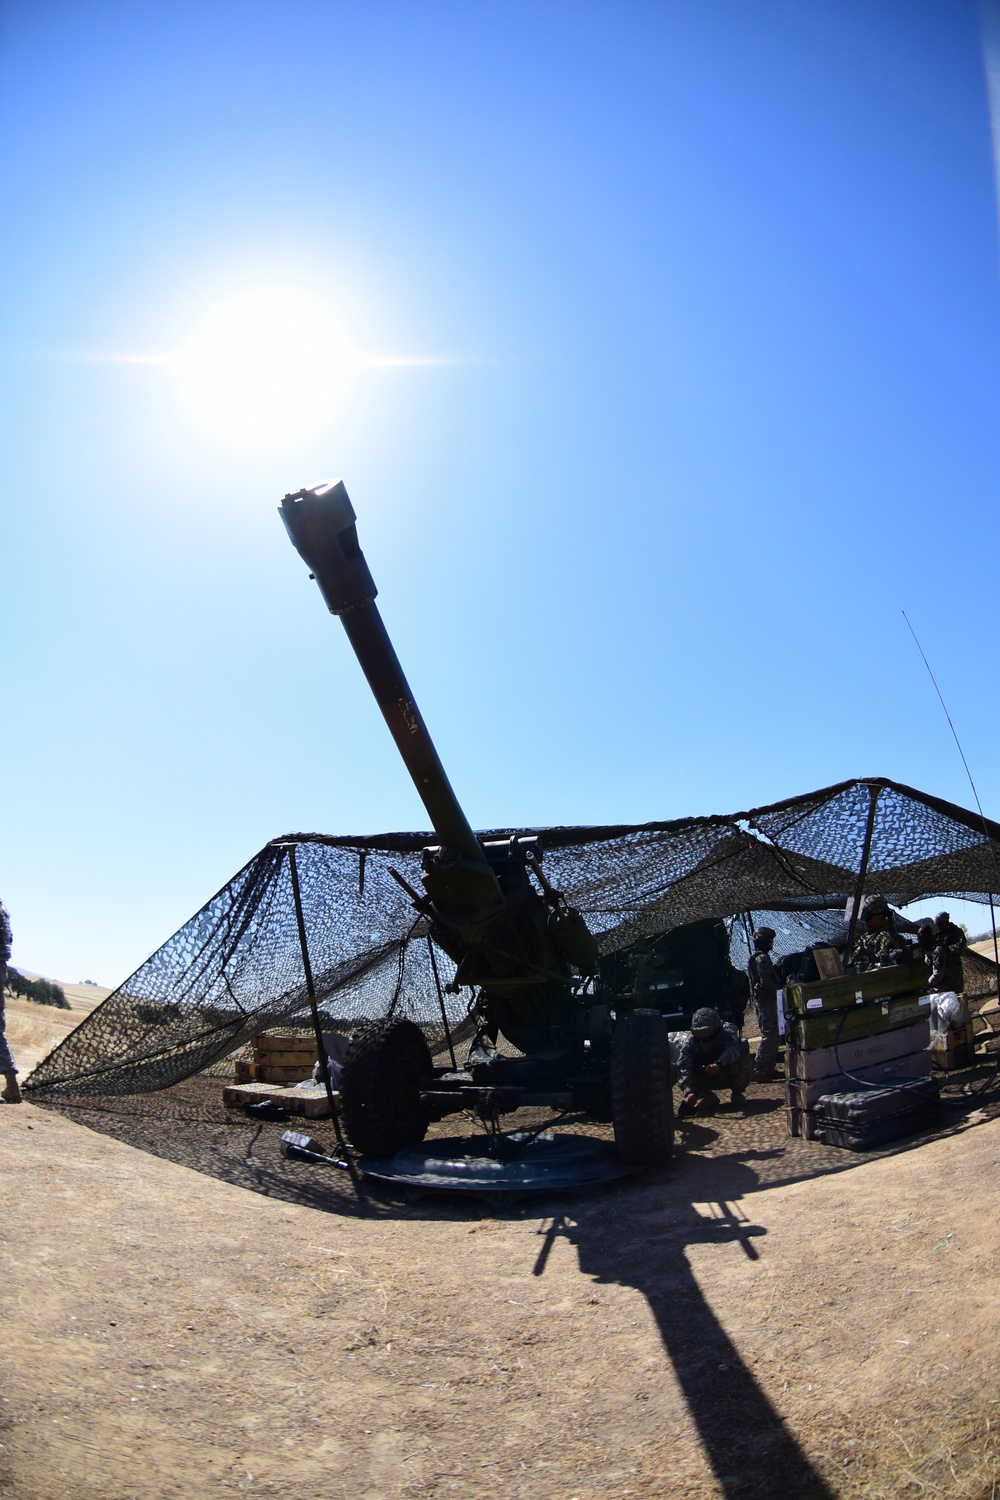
[25,779,1000,1098]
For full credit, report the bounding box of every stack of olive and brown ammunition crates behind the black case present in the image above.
[784,960,931,1140]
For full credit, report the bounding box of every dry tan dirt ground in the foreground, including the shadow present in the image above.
[0,1038,1000,1500]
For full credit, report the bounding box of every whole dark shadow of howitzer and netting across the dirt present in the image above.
[29,1077,1000,1500]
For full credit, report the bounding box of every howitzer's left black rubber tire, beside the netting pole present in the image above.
[340,1020,433,1157]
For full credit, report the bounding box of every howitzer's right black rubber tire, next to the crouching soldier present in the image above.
[612,1011,673,1167]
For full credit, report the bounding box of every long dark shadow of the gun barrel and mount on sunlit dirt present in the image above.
[534,1130,834,1500]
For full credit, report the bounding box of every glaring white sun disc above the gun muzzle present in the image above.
[179,291,346,447]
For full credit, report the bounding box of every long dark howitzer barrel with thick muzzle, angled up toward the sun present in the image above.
[279,480,499,876]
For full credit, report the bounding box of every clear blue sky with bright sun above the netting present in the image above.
[0,0,1000,984]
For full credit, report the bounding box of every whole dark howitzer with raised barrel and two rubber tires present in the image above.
[280,480,673,1164]
